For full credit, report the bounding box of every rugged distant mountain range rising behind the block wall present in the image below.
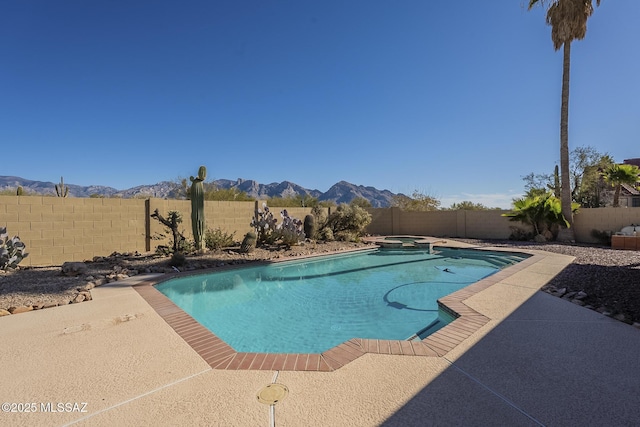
[0,176,397,208]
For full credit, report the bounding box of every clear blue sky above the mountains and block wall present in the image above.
[0,0,640,208]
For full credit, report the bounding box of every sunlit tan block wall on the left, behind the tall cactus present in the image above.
[0,196,318,266]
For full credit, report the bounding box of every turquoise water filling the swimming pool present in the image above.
[156,248,526,353]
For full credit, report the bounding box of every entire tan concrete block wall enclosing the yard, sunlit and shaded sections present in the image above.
[6,196,640,266]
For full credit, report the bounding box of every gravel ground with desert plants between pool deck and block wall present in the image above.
[0,239,640,323]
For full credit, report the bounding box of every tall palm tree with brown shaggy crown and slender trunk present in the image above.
[529,0,600,241]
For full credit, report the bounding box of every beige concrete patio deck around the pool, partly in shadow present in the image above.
[0,244,640,426]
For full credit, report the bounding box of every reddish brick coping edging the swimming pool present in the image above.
[133,248,544,372]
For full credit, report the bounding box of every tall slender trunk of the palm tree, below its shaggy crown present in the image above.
[558,41,575,242]
